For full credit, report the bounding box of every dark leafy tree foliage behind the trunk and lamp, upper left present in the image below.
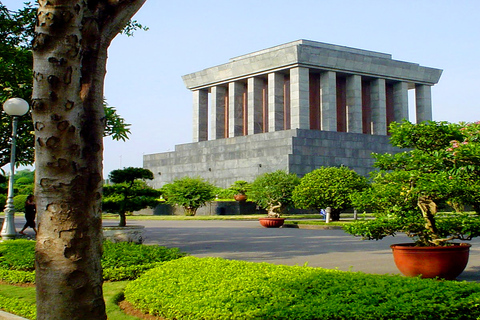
[0,3,131,168]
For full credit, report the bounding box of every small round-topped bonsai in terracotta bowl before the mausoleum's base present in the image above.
[249,170,300,228]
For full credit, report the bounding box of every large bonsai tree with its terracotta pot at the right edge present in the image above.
[344,121,480,279]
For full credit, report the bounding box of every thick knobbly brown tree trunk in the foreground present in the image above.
[32,0,146,320]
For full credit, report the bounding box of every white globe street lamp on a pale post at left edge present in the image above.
[0,98,29,240]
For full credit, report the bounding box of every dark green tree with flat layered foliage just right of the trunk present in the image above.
[102,167,160,227]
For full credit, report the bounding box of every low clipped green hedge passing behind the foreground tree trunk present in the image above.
[0,240,185,283]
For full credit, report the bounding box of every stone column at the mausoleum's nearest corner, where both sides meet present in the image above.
[290,67,310,129]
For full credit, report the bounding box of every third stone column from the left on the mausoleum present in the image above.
[228,81,245,138]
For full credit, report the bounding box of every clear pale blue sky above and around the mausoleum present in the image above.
[2,0,480,175]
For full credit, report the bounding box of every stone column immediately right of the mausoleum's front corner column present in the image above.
[320,71,337,131]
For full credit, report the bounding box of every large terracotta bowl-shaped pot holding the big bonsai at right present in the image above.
[390,243,471,280]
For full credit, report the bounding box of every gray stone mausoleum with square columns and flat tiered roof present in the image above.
[143,40,442,188]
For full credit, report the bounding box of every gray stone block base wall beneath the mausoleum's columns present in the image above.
[143,129,399,188]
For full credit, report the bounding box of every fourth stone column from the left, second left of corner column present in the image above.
[247,77,263,135]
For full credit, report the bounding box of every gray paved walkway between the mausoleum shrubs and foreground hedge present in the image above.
[104,217,480,281]
